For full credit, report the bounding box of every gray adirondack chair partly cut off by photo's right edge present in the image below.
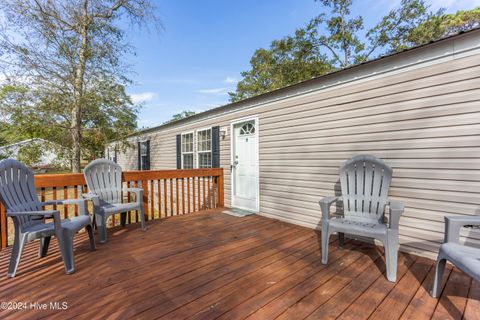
[431,216,480,298]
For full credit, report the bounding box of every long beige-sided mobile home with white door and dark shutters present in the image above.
[108,29,480,257]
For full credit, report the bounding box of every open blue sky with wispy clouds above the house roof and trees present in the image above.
[127,0,480,128]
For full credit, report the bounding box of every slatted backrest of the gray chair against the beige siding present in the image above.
[340,155,392,222]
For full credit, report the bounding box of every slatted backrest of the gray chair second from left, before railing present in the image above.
[84,159,122,203]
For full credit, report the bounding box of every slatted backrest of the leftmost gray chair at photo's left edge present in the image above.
[0,159,42,225]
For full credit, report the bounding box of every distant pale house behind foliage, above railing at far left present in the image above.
[0,138,69,169]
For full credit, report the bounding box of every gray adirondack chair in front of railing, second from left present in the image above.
[84,159,146,243]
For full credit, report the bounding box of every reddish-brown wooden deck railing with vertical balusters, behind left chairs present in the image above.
[0,168,224,249]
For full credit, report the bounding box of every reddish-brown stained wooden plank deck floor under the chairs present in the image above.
[0,210,480,320]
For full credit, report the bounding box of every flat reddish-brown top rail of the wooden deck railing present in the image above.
[35,168,223,188]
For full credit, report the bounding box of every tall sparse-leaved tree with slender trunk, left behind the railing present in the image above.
[0,0,158,172]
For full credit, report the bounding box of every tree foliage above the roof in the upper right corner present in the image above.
[404,7,480,49]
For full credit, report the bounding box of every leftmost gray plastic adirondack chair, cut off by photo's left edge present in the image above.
[0,159,95,278]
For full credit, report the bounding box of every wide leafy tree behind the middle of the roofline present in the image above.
[230,0,433,101]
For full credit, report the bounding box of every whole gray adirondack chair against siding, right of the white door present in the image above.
[320,155,404,282]
